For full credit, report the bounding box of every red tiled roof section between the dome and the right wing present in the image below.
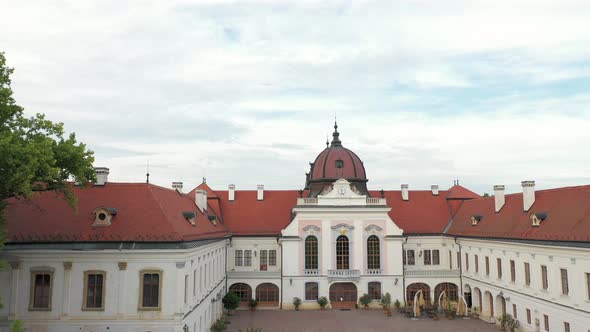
[370,190,450,234]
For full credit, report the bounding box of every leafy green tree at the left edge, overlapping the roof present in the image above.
[0,52,95,247]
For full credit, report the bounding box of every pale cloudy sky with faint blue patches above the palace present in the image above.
[0,0,590,194]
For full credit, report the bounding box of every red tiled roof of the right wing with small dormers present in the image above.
[447,185,590,241]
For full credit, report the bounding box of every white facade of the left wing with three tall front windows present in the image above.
[0,239,228,332]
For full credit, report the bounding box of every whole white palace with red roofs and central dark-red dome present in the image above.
[0,126,590,332]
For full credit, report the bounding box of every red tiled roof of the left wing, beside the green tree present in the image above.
[5,183,229,242]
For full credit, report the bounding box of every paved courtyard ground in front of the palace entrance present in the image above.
[228,310,499,332]
